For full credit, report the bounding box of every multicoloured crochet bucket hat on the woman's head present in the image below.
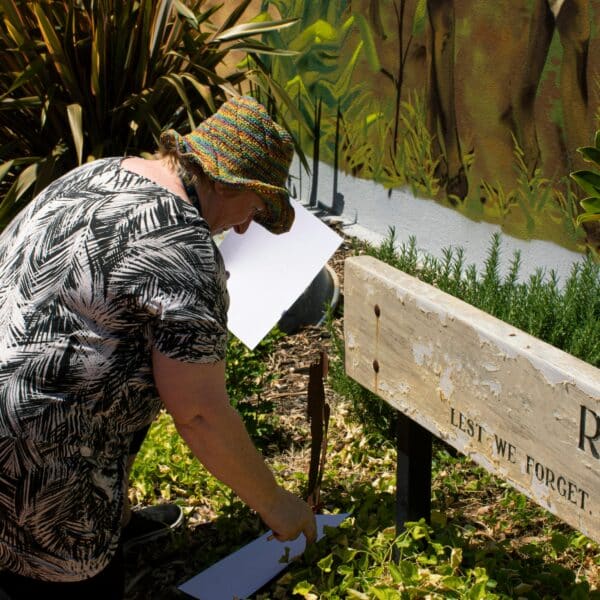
[160,96,294,233]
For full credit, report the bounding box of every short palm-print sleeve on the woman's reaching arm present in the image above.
[113,224,229,363]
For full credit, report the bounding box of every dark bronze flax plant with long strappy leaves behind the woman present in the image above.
[0,0,294,229]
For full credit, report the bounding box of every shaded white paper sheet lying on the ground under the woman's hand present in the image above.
[179,513,348,600]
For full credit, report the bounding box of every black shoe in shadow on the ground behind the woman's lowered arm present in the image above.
[121,504,183,552]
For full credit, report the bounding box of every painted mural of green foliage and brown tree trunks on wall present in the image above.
[248,0,600,250]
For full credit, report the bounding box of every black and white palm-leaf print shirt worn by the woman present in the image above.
[0,158,228,581]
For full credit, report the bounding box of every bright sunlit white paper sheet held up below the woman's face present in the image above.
[219,201,342,349]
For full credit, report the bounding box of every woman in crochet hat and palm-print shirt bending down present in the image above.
[0,97,316,599]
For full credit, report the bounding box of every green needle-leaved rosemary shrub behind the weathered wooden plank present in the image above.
[330,233,600,434]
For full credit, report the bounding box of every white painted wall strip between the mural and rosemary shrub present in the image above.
[291,160,584,283]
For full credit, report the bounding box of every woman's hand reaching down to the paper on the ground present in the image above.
[260,487,317,544]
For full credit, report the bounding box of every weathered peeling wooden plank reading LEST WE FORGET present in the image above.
[344,256,600,541]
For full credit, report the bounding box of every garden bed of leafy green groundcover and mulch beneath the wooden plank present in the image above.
[127,232,600,600]
